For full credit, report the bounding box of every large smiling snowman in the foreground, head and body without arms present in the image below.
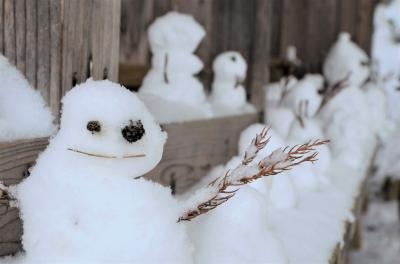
[15,80,192,263]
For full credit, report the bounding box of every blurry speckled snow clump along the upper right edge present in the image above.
[372,0,400,122]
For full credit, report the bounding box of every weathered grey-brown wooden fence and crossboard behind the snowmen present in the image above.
[0,0,375,255]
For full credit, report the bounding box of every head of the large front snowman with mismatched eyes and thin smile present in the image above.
[52,80,167,176]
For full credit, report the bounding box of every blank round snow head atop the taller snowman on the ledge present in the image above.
[148,12,206,53]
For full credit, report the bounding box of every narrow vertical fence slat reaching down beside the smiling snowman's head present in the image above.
[49,0,62,120]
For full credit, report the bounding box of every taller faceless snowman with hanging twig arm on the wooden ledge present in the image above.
[139,12,211,123]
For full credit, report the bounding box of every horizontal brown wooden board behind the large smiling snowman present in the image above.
[0,114,259,256]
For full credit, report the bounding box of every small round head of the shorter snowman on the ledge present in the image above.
[213,51,247,85]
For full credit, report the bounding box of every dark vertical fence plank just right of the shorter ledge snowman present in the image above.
[247,0,274,110]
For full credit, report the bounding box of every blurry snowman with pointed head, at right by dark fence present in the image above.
[318,33,382,167]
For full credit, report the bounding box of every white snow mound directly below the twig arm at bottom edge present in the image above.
[188,186,287,264]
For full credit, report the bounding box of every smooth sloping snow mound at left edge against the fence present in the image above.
[0,55,55,141]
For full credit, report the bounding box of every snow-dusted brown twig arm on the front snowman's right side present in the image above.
[178,129,329,222]
